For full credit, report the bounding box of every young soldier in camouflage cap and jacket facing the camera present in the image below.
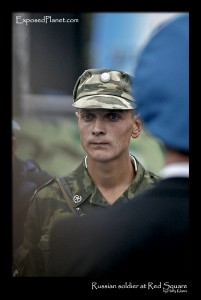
[16,69,159,276]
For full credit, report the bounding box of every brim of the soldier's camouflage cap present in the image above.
[73,95,135,109]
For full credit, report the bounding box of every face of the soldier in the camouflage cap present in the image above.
[76,109,141,162]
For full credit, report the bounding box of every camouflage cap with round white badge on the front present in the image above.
[73,69,136,109]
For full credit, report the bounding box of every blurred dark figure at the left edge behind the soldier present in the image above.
[12,120,52,274]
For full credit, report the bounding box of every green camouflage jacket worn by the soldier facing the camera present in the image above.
[16,158,160,276]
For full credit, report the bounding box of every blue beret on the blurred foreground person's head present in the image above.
[133,13,189,152]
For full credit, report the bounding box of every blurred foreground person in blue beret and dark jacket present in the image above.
[48,14,190,282]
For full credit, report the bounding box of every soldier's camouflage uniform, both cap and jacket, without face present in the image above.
[16,69,159,276]
